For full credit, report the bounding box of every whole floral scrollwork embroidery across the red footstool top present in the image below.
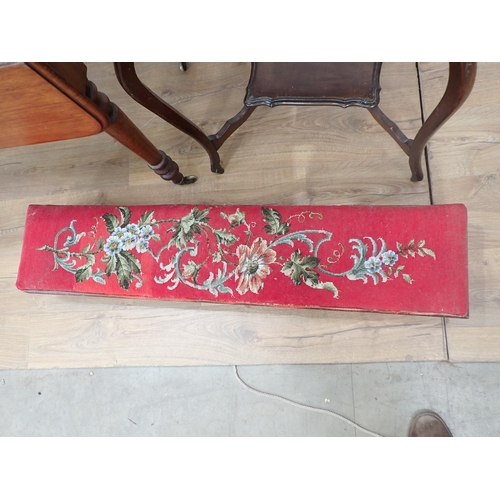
[38,207,436,298]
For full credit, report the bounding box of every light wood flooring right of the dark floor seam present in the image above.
[422,63,500,361]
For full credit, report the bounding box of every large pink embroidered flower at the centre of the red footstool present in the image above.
[235,238,276,295]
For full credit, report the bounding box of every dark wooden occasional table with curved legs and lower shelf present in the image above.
[115,62,477,181]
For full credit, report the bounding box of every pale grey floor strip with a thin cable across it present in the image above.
[0,362,500,437]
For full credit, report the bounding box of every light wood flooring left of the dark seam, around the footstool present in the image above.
[0,63,448,368]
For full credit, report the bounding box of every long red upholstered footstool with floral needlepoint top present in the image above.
[17,205,468,317]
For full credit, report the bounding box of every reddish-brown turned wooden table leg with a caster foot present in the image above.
[88,82,196,184]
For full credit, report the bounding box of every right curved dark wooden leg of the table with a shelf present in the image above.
[409,63,477,181]
